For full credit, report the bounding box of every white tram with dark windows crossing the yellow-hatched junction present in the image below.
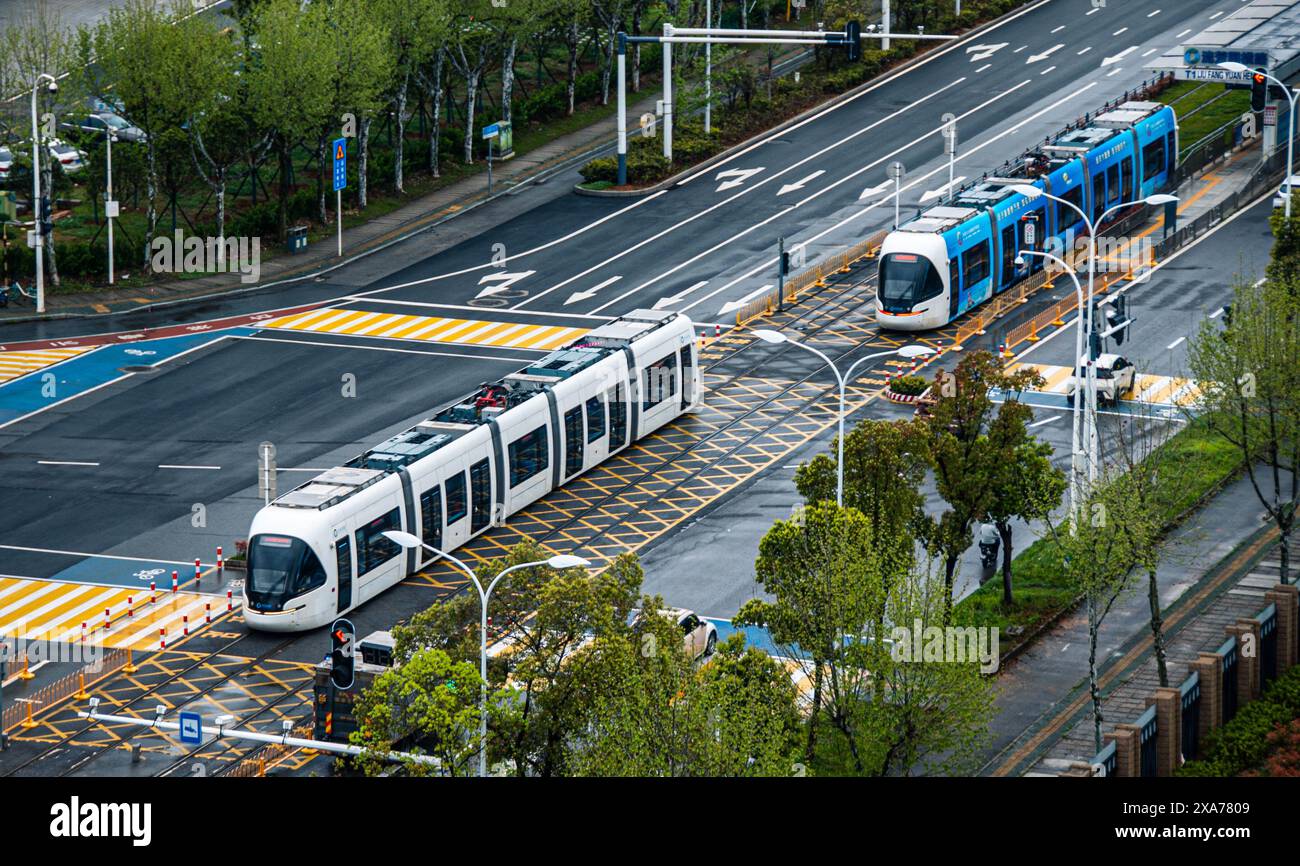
[243,309,703,632]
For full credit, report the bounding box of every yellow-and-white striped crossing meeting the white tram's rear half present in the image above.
[259,307,588,351]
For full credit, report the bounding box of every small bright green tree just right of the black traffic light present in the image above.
[350,649,482,776]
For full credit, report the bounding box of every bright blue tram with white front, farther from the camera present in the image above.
[876,101,1178,330]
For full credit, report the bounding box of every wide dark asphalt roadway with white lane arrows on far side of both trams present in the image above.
[0,0,1258,614]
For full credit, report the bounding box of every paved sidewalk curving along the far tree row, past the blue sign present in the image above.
[0,91,658,322]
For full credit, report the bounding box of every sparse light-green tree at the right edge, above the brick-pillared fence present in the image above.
[1188,271,1300,581]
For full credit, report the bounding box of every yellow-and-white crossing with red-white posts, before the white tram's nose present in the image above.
[0,577,226,650]
